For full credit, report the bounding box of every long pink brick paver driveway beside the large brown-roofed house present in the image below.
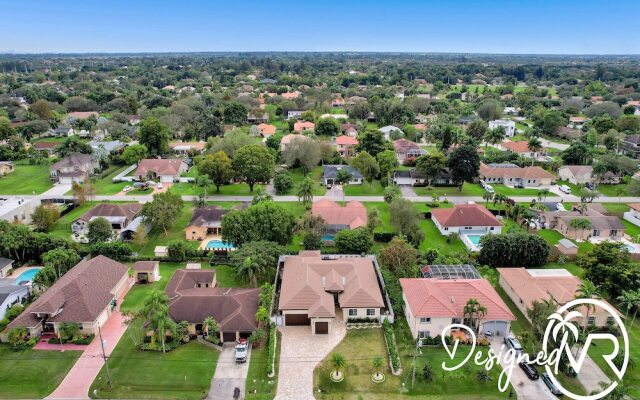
[47,281,132,399]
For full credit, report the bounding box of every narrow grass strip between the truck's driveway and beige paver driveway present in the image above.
[244,332,281,400]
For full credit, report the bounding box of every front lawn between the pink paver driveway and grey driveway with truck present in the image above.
[89,328,219,400]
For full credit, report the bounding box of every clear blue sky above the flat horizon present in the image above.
[0,0,640,54]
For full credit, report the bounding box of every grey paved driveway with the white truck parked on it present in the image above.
[206,343,251,400]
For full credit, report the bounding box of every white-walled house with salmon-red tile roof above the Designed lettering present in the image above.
[400,278,516,339]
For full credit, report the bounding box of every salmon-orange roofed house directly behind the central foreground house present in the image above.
[311,199,368,233]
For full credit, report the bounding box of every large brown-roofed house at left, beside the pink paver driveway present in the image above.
[2,256,129,340]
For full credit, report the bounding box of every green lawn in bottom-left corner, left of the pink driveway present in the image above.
[0,344,82,399]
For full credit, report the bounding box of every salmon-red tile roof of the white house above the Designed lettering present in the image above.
[400,278,516,321]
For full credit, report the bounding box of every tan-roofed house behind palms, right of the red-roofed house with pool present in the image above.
[540,209,627,241]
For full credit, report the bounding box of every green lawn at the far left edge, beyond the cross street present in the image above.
[0,163,53,194]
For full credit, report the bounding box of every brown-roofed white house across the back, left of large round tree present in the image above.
[71,203,142,235]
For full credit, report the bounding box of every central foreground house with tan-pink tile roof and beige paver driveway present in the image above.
[276,251,393,334]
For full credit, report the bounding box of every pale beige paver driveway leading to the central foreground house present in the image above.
[275,310,347,400]
